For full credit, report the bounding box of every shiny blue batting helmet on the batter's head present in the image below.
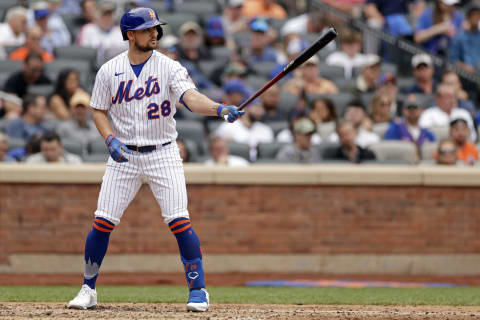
[120,8,166,40]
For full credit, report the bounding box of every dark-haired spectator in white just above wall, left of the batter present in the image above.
[25,131,82,164]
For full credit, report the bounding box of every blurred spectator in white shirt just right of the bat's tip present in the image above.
[326,29,368,79]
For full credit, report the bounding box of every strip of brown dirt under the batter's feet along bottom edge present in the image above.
[0,302,480,320]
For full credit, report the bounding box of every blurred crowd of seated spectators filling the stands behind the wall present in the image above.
[0,0,480,166]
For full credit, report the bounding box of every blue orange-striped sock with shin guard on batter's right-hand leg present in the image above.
[168,218,205,290]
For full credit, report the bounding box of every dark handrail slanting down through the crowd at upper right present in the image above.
[309,0,480,85]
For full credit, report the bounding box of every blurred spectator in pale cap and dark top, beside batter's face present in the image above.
[178,21,211,63]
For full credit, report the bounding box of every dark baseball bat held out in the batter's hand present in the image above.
[234,28,338,114]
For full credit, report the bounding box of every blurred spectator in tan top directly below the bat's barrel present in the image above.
[283,56,338,98]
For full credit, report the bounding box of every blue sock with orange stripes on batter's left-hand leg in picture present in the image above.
[83,217,115,289]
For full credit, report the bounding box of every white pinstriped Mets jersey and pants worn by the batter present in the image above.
[90,51,195,224]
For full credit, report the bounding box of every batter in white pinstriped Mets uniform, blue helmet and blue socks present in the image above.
[68,8,243,311]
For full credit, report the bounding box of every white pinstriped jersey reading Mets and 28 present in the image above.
[90,50,195,146]
